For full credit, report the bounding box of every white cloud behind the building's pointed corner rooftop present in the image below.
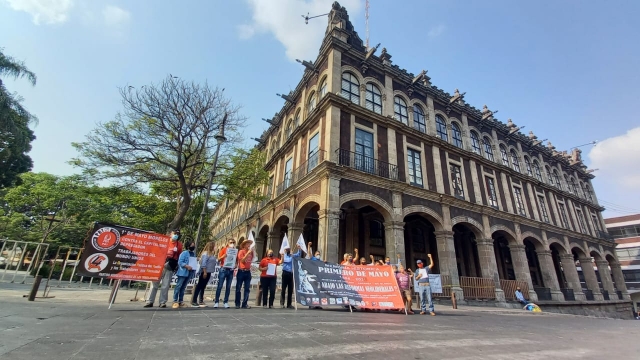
[238,0,364,60]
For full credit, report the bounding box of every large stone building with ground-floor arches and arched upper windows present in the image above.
[210,3,628,301]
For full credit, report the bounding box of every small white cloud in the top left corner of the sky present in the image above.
[4,0,74,25]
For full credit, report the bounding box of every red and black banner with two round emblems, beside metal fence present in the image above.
[78,223,169,281]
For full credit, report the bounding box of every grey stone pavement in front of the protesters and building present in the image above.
[0,284,640,360]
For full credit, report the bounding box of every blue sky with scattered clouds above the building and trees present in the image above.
[0,0,640,216]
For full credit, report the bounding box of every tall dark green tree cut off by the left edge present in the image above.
[0,48,37,189]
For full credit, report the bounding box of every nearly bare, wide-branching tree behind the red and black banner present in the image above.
[71,76,264,229]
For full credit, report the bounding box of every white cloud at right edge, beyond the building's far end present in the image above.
[589,127,640,191]
